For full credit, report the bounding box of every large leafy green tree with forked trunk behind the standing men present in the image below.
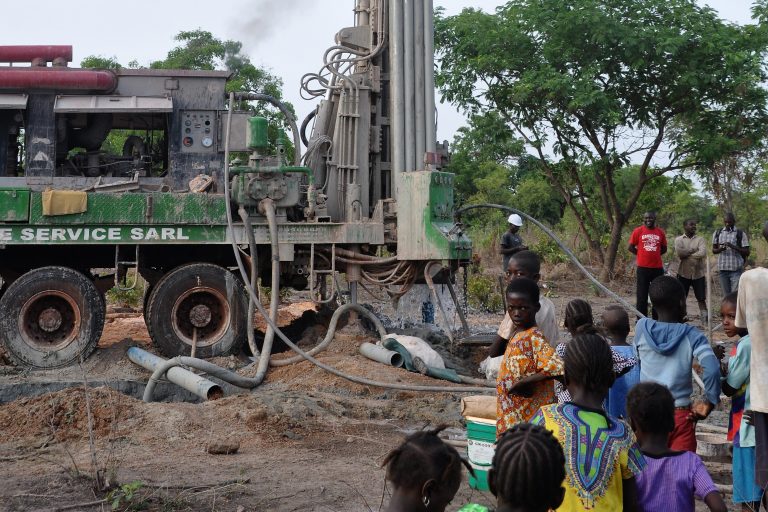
[435,0,766,279]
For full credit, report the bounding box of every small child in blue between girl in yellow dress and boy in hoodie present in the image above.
[602,305,640,418]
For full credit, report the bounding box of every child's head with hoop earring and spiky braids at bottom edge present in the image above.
[382,427,472,512]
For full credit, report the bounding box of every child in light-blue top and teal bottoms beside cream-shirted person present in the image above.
[720,292,762,512]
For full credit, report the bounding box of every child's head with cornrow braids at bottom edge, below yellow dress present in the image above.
[488,423,565,512]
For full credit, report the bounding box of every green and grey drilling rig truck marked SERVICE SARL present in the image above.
[0,0,471,369]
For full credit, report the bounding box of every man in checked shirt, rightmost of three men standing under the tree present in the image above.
[712,212,750,296]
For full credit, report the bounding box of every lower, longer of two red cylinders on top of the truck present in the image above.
[0,67,117,92]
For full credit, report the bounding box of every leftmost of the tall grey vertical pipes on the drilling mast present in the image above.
[389,1,405,190]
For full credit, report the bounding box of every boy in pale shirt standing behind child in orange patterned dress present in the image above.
[488,251,560,357]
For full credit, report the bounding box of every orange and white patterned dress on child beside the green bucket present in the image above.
[496,326,563,437]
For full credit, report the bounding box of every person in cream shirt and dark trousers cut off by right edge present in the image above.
[736,222,768,508]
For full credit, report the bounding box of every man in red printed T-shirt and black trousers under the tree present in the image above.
[629,212,667,318]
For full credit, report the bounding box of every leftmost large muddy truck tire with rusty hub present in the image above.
[0,267,106,369]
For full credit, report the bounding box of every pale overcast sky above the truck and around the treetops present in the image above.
[0,0,751,145]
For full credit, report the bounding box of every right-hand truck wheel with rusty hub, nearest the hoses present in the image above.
[146,263,248,357]
